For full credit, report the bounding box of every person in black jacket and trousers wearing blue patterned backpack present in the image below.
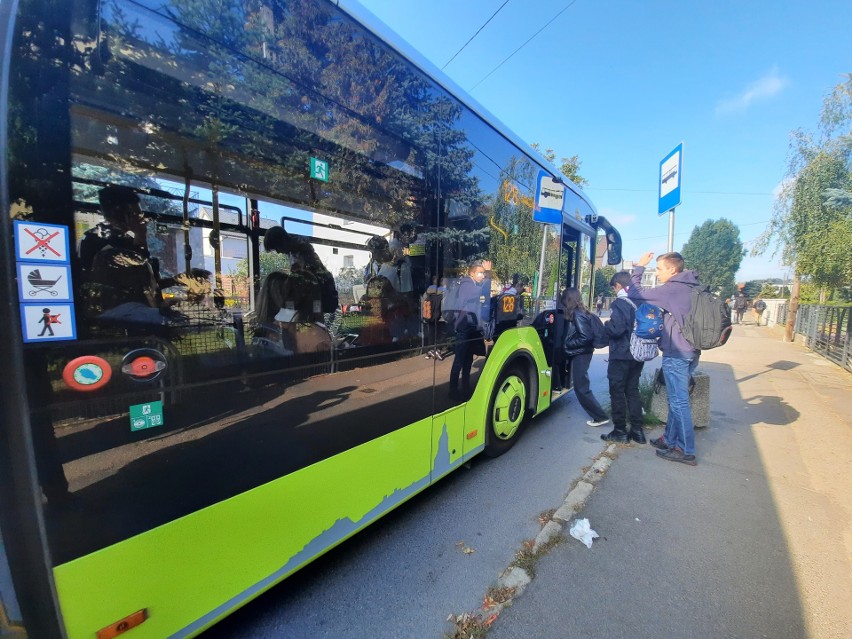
[601,271,647,444]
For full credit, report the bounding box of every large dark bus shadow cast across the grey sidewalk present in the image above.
[488,361,806,639]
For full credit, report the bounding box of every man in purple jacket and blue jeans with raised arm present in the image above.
[627,253,701,466]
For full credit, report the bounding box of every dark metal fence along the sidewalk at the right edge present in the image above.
[779,305,852,371]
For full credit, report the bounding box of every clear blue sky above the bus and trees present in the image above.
[359,0,852,281]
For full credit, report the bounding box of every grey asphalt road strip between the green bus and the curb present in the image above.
[203,355,606,639]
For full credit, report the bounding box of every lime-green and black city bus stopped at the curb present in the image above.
[0,0,620,639]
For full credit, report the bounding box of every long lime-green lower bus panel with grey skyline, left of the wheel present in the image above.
[54,419,434,639]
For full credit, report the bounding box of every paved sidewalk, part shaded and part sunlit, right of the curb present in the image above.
[488,325,852,639]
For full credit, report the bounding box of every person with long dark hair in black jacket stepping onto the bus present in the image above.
[559,287,609,426]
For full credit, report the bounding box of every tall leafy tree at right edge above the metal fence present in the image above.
[755,75,852,289]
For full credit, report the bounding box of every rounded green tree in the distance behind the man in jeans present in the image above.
[681,218,745,297]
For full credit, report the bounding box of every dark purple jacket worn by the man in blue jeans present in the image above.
[627,266,699,359]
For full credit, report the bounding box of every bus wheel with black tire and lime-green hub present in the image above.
[483,365,530,457]
